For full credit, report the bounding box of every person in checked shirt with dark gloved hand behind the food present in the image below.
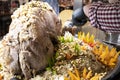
[72,0,120,46]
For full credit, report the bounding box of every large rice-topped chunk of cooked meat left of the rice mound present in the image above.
[0,1,61,80]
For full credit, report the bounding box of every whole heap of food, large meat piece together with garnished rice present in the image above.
[0,1,120,80]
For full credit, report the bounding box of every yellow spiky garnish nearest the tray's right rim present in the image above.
[93,44,119,67]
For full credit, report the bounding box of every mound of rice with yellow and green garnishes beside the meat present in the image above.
[31,32,119,80]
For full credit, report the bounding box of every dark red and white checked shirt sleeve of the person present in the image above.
[89,2,120,33]
